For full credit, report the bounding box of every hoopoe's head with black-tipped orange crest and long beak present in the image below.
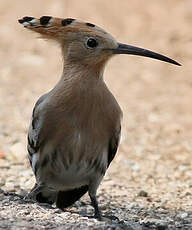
[19,16,180,66]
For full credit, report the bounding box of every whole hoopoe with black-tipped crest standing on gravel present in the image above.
[18,16,181,220]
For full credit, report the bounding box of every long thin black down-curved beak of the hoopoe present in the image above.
[113,43,181,66]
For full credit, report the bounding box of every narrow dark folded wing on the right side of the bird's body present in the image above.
[108,125,121,167]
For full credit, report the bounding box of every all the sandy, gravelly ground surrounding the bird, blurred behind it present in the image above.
[0,0,192,230]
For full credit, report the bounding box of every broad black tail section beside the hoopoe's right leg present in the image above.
[56,185,88,209]
